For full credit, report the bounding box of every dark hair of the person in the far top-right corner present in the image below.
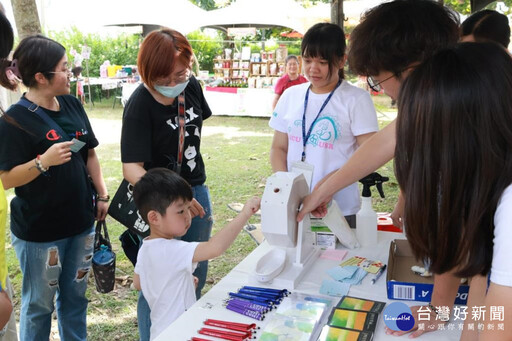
[461,9,510,48]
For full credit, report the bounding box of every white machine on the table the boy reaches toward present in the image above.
[254,172,358,289]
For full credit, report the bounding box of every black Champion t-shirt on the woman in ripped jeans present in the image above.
[0,95,98,242]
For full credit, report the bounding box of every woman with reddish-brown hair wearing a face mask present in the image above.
[121,28,212,340]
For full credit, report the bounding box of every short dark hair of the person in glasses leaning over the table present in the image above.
[348,0,459,77]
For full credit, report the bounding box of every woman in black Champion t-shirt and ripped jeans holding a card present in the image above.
[0,35,108,341]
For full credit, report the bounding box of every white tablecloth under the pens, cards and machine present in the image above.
[155,232,461,341]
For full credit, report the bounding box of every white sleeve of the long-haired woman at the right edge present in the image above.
[491,185,512,287]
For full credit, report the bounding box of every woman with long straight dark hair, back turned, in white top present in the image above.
[390,43,512,341]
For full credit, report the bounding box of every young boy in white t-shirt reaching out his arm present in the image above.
[133,168,260,340]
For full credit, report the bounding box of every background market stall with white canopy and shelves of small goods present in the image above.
[202,0,320,117]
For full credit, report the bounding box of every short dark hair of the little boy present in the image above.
[133,168,194,223]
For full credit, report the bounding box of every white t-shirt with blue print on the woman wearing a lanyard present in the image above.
[269,80,379,215]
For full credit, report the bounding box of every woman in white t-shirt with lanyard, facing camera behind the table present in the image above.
[269,23,378,227]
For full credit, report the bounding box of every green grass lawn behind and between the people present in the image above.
[2,96,398,341]
